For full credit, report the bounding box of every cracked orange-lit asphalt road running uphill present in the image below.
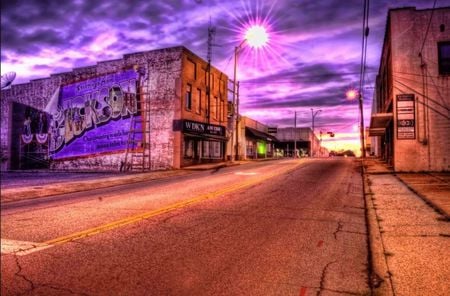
[1,159,370,296]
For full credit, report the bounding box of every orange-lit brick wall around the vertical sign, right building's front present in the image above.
[390,8,450,171]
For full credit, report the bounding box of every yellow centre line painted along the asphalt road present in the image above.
[43,163,301,245]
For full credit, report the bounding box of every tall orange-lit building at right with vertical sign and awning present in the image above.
[369,7,450,171]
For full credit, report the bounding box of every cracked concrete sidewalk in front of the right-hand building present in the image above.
[364,159,450,296]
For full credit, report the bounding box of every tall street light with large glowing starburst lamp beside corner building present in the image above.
[231,25,269,160]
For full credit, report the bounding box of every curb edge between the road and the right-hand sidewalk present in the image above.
[361,161,394,296]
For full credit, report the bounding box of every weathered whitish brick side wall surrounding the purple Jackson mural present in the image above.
[0,47,183,171]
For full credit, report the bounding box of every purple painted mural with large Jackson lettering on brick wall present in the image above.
[46,70,142,159]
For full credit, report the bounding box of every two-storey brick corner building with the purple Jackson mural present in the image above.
[0,47,228,171]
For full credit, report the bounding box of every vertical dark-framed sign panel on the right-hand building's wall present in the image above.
[397,94,416,140]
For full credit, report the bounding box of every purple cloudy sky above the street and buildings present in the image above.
[1,0,438,153]
